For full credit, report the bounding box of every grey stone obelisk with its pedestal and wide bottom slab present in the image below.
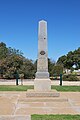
[26,20,59,97]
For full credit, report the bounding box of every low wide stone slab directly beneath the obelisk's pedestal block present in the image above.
[26,90,60,97]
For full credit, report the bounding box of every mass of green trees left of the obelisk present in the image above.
[0,42,35,78]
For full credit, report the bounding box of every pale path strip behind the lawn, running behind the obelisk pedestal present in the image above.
[0,79,80,86]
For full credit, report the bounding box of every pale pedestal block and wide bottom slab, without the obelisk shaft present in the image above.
[26,79,60,97]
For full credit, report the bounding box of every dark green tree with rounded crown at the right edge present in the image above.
[57,48,80,69]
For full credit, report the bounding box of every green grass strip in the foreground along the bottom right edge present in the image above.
[31,115,80,120]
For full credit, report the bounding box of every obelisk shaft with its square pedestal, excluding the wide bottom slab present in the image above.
[34,20,51,91]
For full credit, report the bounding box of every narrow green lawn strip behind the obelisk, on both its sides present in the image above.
[0,85,80,92]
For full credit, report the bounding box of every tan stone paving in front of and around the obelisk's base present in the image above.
[0,92,80,120]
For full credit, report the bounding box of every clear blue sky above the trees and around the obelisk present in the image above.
[0,0,80,61]
